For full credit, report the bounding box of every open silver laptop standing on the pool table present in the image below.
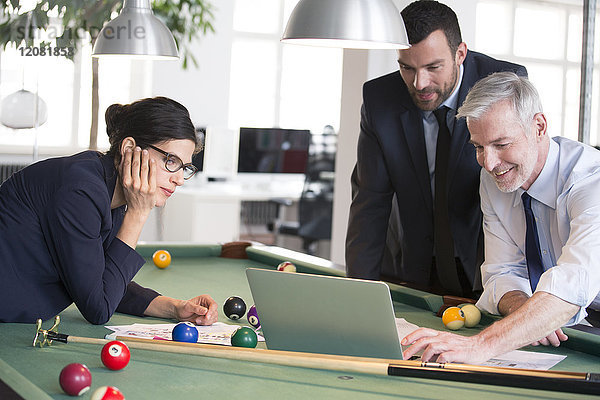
[246,268,402,359]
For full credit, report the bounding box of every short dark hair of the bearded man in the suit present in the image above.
[401,0,462,55]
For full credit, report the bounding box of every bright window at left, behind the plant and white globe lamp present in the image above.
[0,10,137,154]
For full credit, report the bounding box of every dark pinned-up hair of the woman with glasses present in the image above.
[105,97,200,162]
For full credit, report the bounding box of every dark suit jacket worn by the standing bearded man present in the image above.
[346,51,527,292]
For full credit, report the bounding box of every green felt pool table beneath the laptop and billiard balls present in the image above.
[0,245,600,400]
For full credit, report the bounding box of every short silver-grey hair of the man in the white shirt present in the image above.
[456,72,543,130]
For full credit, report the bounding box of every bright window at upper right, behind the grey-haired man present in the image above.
[475,0,600,145]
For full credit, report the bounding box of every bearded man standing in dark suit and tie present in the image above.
[346,1,526,297]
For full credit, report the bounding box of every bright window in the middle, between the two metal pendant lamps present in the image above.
[229,0,342,133]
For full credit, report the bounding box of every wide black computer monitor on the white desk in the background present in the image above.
[238,128,311,174]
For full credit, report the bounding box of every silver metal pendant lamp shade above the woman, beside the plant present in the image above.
[92,0,179,59]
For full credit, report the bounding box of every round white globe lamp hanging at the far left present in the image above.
[0,89,48,129]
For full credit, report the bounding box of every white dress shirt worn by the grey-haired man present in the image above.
[477,137,600,325]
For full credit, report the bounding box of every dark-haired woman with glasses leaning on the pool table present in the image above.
[0,97,218,325]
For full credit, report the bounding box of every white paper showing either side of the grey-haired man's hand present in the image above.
[396,318,567,371]
